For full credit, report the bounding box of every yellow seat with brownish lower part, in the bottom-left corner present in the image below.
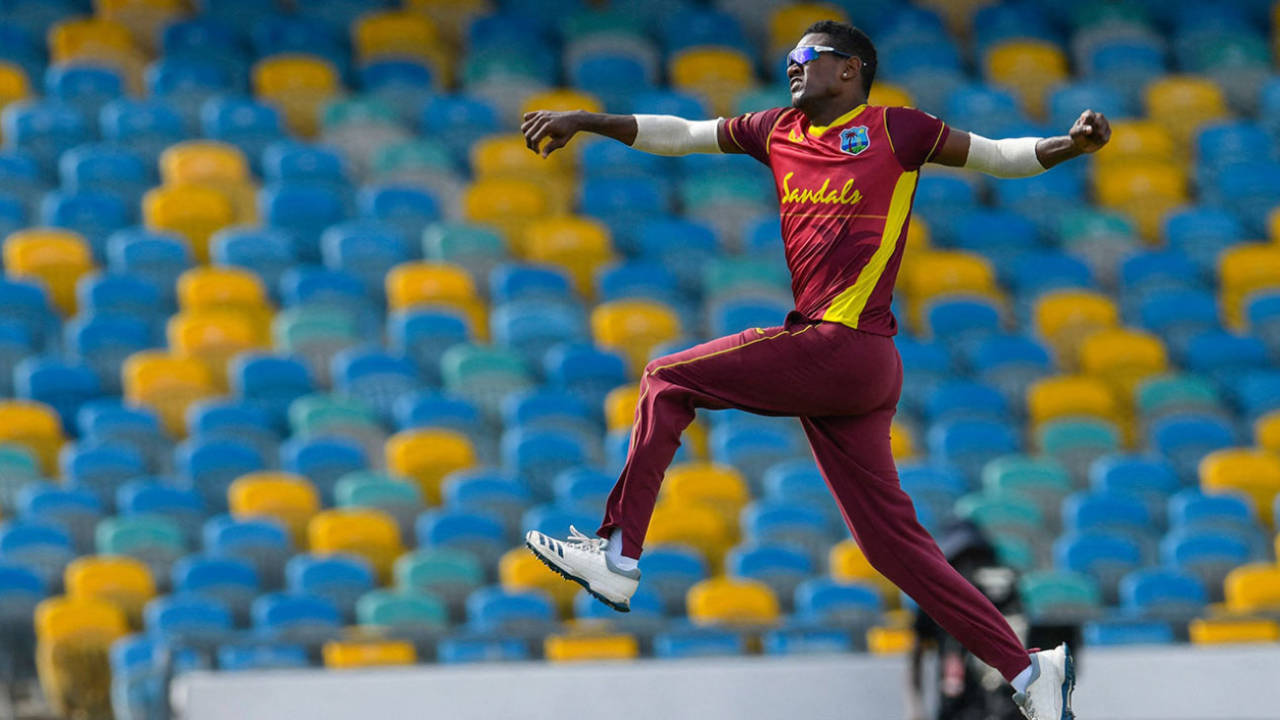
[36,597,128,717]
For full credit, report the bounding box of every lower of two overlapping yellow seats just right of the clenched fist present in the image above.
[1093,160,1188,242]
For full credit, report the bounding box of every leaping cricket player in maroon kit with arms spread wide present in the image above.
[521,20,1111,720]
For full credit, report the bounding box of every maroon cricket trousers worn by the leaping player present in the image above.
[598,313,1030,679]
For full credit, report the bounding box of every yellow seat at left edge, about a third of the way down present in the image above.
[4,228,93,316]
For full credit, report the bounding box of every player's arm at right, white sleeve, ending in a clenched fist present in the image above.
[932,110,1111,178]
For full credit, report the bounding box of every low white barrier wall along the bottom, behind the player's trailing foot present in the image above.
[174,646,1280,720]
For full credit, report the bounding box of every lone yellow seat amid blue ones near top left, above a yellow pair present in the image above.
[252,54,342,137]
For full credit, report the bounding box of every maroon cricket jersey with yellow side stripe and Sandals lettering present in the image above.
[726,105,950,336]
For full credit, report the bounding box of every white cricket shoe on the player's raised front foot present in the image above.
[525,525,640,612]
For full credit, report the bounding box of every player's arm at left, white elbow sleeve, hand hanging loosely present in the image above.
[520,110,741,158]
